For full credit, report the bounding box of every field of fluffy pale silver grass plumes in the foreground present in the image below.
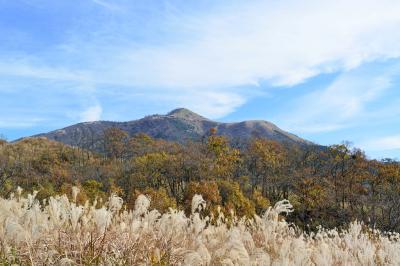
[0,188,400,265]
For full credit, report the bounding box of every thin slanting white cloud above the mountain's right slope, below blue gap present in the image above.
[281,67,397,133]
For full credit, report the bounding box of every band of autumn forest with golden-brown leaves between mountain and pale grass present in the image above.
[0,128,400,231]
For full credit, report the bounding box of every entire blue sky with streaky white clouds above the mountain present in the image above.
[0,0,400,158]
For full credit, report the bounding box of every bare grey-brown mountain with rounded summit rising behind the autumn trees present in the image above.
[28,108,312,147]
